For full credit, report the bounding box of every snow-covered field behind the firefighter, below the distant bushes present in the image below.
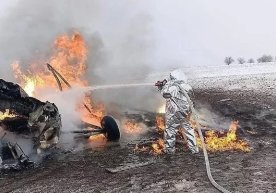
[146,62,276,96]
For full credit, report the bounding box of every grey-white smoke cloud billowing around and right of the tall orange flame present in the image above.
[0,0,164,111]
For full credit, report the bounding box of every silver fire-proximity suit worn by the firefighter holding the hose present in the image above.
[160,70,198,153]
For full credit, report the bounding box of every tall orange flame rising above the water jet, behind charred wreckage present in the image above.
[12,33,87,96]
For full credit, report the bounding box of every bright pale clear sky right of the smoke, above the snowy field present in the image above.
[154,0,276,65]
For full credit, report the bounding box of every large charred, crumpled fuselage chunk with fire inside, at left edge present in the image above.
[0,79,61,149]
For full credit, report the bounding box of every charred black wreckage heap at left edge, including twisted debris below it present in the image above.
[0,79,61,168]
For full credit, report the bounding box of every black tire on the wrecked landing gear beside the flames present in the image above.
[101,116,120,141]
